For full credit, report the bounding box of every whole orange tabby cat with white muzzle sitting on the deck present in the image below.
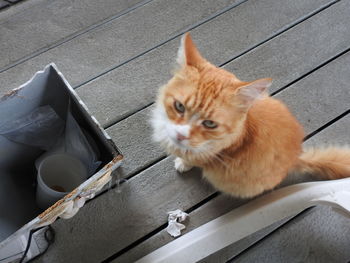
[152,34,350,197]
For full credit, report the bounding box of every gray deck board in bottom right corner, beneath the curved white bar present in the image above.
[234,207,350,263]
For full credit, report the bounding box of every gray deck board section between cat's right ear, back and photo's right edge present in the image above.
[275,51,350,134]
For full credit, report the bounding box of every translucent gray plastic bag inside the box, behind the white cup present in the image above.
[0,105,101,175]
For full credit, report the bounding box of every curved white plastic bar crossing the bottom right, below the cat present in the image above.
[137,178,350,263]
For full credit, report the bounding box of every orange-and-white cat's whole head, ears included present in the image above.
[152,35,271,157]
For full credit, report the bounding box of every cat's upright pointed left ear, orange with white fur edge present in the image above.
[176,33,205,67]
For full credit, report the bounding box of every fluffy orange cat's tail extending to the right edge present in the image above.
[293,147,350,180]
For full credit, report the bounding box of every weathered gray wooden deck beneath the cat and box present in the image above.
[0,0,350,263]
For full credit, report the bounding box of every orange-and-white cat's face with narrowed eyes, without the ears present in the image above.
[153,68,245,156]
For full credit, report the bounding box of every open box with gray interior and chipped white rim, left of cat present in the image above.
[0,64,123,262]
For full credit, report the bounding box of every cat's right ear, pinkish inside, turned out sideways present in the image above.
[237,78,272,107]
